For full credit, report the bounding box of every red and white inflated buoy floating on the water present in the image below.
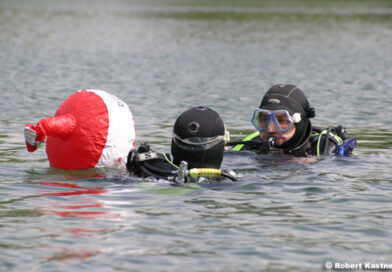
[25,90,136,170]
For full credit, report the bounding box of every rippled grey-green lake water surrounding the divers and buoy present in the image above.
[0,0,392,271]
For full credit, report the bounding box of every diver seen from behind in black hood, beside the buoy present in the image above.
[126,106,236,184]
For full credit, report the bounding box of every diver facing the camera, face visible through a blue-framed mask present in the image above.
[228,84,357,157]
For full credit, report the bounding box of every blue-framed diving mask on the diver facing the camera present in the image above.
[252,109,301,133]
